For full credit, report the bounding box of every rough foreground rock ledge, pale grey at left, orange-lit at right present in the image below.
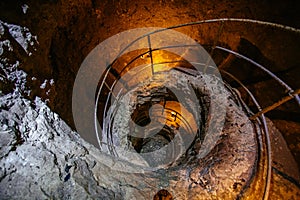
[0,90,256,199]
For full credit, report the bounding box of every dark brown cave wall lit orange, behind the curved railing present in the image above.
[0,0,300,197]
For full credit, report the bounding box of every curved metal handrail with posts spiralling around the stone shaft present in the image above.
[95,18,300,199]
